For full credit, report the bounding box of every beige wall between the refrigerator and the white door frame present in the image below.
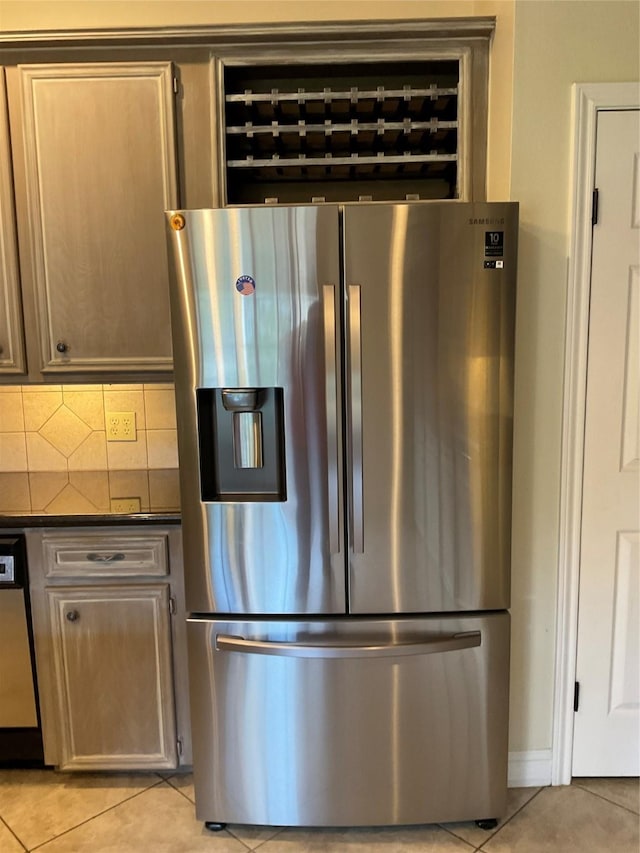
[511,0,640,750]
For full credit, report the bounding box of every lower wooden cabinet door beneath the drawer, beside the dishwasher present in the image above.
[47,584,177,770]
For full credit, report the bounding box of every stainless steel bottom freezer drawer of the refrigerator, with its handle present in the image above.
[188,613,509,826]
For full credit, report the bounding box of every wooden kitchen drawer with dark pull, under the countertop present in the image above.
[42,532,169,579]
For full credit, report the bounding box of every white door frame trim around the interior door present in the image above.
[551,83,640,785]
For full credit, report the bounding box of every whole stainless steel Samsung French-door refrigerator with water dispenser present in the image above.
[167,201,517,826]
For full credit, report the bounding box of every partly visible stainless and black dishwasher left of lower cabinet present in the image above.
[0,534,43,767]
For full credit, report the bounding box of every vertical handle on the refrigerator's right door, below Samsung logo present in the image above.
[347,284,364,554]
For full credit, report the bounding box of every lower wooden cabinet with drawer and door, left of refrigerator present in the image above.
[27,527,191,770]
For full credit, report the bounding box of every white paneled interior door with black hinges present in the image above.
[572,105,640,776]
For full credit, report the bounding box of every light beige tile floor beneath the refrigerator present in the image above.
[0,770,640,853]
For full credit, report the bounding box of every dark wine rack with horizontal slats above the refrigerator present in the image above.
[223,59,464,204]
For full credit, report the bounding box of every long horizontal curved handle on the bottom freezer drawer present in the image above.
[216,631,482,658]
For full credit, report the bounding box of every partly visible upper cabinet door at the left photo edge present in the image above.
[0,68,25,374]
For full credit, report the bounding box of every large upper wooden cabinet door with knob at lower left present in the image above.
[20,62,177,372]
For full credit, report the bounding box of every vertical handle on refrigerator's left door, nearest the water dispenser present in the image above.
[322,284,340,554]
